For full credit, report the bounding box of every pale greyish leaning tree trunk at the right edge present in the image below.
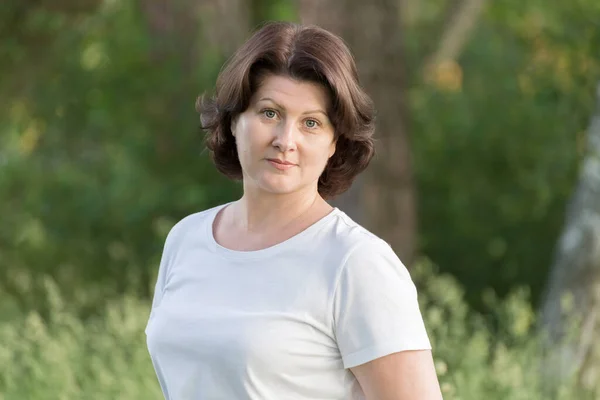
[541,81,600,387]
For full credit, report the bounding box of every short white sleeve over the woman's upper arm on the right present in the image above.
[333,238,431,368]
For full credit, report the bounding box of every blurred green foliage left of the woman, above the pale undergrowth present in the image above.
[0,1,239,312]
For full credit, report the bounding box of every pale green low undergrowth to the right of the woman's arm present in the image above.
[412,260,600,400]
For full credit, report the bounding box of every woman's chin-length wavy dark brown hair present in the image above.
[196,22,375,199]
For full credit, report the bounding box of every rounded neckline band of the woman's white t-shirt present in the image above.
[205,202,340,260]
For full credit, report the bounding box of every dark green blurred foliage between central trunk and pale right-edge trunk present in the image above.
[408,0,600,309]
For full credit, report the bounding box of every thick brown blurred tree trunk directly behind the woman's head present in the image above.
[299,0,417,265]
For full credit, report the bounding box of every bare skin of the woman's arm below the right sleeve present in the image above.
[350,350,442,400]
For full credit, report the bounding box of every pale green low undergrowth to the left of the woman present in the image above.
[0,278,162,400]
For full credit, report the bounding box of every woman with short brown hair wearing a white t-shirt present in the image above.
[146,23,441,400]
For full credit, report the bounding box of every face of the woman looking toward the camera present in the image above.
[231,75,335,194]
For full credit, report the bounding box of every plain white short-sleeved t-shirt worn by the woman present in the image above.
[146,206,431,400]
